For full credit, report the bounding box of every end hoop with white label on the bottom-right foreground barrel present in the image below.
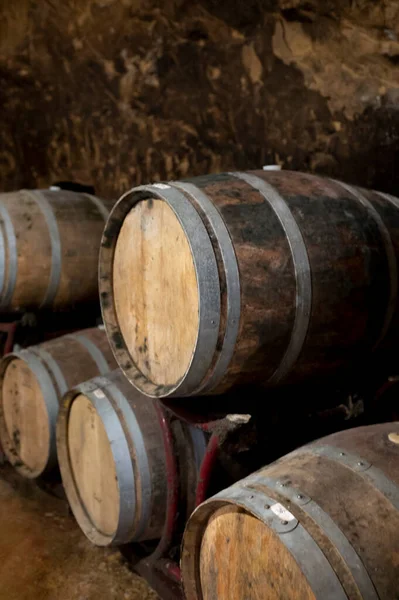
[208,488,347,600]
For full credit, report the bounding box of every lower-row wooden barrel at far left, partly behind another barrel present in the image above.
[0,328,116,478]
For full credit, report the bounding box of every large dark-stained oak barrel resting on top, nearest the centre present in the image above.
[100,171,399,397]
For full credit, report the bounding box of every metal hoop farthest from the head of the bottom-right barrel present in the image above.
[304,445,399,510]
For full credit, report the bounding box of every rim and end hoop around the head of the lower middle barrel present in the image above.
[56,376,136,546]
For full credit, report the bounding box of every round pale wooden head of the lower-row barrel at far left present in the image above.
[2,358,50,473]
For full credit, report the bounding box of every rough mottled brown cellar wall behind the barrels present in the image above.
[0,0,399,195]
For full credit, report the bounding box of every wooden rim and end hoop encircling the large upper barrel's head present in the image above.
[99,183,221,398]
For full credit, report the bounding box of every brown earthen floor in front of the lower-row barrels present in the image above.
[0,467,158,600]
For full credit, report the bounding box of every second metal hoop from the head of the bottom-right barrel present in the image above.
[249,473,379,600]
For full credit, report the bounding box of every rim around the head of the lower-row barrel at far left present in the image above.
[0,349,58,479]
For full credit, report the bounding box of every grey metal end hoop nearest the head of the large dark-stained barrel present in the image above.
[123,183,220,397]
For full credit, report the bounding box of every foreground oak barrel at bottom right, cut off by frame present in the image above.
[181,423,399,600]
